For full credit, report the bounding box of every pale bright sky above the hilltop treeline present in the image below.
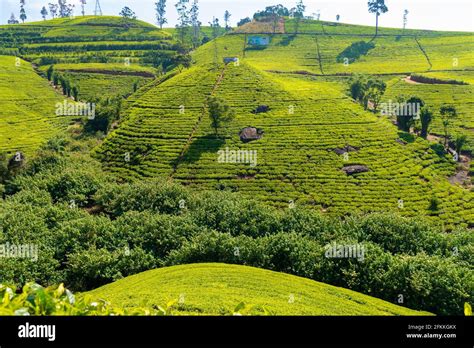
[0,0,474,31]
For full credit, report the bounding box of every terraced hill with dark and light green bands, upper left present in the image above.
[0,16,185,100]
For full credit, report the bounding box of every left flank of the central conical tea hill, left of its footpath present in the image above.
[95,67,223,176]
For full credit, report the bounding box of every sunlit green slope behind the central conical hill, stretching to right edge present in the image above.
[196,21,474,154]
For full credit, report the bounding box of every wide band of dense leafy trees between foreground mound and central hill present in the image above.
[0,140,474,315]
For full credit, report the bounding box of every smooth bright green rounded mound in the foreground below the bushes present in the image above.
[87,264,428,315]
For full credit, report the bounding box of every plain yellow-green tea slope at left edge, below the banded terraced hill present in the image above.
[0,56,69,155]
